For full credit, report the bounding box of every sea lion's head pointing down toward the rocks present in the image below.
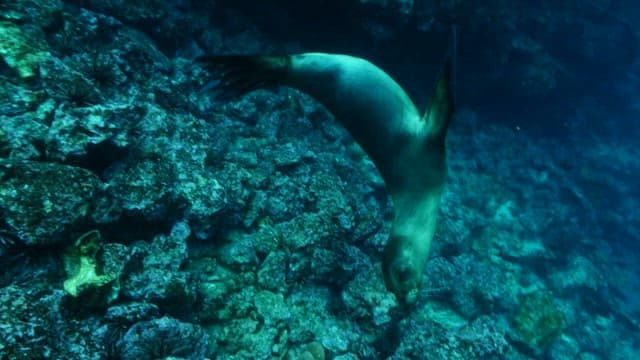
[382,235,424,304]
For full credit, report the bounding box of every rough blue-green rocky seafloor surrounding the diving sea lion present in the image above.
[0,0,640,360]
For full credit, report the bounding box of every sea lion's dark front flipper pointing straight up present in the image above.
[422,27,456,144]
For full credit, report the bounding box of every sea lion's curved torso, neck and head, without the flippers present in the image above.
[285,53,447,300]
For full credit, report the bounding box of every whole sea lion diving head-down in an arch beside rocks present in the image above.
[196,30,455,303]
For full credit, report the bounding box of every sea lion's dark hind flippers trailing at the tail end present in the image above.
[195,55,289,100]
